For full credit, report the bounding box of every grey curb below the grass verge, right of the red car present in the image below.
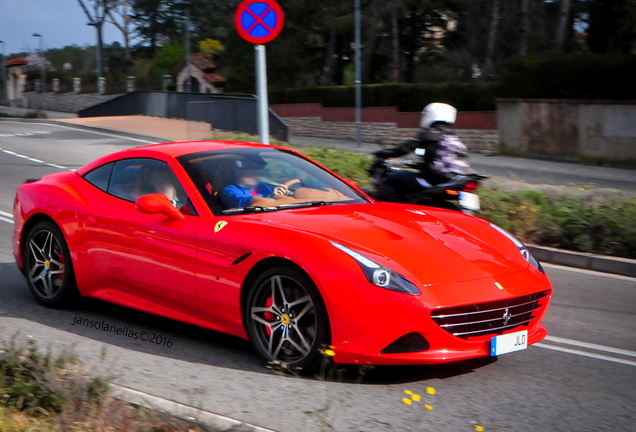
[527,245,636,277]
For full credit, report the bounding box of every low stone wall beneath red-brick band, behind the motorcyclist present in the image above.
[284,117,499,152]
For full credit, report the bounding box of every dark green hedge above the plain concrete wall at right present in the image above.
[495,53,636,100]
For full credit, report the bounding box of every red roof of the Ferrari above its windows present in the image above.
[77,140,288,176]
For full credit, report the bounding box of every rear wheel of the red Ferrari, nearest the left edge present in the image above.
[22,222,78,308]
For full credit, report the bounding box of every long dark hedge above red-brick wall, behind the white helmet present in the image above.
[269,83,495,111]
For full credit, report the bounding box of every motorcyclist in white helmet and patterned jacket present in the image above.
[374,102,468,202]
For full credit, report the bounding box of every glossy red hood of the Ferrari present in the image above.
[253,203,527,285]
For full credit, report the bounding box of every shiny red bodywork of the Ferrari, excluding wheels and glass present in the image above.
[13,142,552,364]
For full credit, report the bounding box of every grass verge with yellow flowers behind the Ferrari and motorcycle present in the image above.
[205,132,636,258]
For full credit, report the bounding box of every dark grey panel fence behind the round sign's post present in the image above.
[78,91,289,141]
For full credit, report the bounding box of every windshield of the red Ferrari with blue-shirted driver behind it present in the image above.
[177,148,368,215]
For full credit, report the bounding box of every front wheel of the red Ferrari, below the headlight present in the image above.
[245,267,330,372]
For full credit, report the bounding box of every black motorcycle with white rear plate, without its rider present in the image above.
[364,157,488,214]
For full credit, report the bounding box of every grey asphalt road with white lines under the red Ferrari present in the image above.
[0,122,636,431]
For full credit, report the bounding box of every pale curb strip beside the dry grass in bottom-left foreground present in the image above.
[110,384,275,432]
